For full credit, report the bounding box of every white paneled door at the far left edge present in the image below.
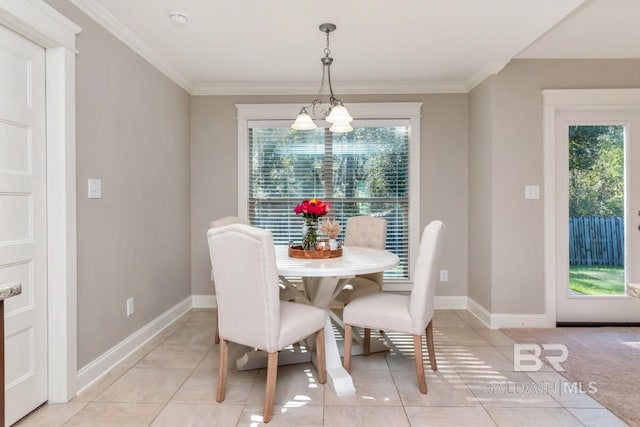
[0,26,47,425]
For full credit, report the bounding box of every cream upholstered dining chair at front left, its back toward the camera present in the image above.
[207,224,327,423]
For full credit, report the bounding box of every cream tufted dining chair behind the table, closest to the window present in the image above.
[335,215,387,304]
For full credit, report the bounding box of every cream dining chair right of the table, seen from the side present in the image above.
[342,221,445,394]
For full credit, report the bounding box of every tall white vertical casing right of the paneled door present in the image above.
[46,47,78,403]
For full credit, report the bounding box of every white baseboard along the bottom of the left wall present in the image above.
[77,297,191,394]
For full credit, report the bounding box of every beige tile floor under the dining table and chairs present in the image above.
[17,309,625,427]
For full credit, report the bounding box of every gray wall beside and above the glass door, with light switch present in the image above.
[469,59,640,314]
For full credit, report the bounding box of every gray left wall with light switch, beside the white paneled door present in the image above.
[47,0,191,368]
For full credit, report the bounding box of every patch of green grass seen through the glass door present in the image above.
[569,265,624,295]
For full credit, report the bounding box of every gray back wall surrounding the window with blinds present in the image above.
[191,94,468,295]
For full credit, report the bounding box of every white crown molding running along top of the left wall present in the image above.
[70,0,193,93]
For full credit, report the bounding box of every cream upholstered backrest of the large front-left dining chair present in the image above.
[207,224,280,352]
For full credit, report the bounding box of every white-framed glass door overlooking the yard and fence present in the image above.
[555,109,640,323]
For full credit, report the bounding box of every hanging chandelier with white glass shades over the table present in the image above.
[291,24,353,133]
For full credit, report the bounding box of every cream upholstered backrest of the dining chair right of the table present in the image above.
[409,221,445,335]
